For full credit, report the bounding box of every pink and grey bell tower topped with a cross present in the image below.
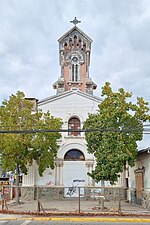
[53,17,97,94]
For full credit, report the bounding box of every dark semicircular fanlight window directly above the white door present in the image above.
[64,149,85,161]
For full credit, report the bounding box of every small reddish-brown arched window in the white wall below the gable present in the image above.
[68,117,81,136]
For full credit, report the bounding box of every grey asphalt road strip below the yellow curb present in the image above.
[0,220,149,225]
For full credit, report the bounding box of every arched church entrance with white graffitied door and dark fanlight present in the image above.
[63,149,86,197]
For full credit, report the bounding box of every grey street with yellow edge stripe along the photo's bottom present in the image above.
[0,214,150,225]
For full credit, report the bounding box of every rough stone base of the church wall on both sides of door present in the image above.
[21,186,129,201]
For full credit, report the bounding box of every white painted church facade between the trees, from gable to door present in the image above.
[35,90,100,186]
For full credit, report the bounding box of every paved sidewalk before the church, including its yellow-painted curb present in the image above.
[0,200,150,223]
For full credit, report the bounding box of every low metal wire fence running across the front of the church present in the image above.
[0,186,150,215]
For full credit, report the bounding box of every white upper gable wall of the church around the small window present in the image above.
[38,90,101,142]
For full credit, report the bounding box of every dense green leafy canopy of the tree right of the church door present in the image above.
[84,82,150,184]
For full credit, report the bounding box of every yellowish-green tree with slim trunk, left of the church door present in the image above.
[0,91,62,202]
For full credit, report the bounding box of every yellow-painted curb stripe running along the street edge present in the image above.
[0,217,150,223]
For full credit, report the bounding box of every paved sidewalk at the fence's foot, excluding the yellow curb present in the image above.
[1,199,150,217]
